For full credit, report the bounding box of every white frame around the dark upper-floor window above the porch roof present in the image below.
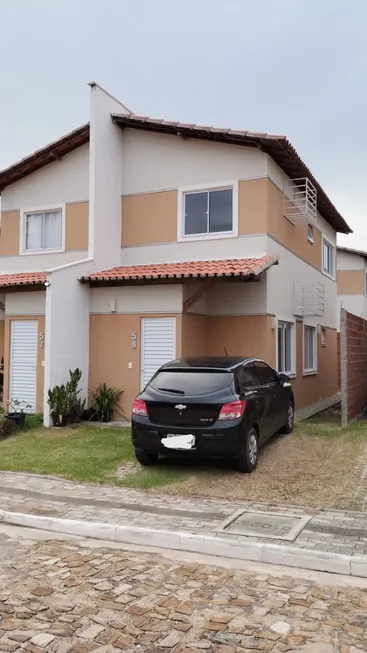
[177,180,238,242]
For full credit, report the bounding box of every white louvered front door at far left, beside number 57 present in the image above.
[9,320,38,413]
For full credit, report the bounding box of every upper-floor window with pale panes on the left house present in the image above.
[23,209,63,252]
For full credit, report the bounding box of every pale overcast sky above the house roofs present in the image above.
[0,0,367,249]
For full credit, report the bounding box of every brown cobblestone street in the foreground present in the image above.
[0,534,367,653]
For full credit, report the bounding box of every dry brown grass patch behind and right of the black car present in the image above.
[162,423,365,510]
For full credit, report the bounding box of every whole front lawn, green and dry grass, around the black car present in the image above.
[0,415,367,509]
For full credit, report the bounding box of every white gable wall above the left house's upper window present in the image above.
[1,144,89,211]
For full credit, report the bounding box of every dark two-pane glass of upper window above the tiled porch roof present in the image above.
[183,188,233,236]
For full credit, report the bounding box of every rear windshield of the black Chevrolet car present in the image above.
[150,370,233,396]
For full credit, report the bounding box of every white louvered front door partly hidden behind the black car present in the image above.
[140,317,176,390]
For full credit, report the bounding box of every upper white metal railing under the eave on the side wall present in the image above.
[283,177,317,224]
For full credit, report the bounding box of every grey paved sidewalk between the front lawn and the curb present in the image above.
[0,472,367,556]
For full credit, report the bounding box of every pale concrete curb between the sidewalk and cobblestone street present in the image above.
[0,510,367,578]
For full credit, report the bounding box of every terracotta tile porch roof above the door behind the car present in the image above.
[80,254,279,283]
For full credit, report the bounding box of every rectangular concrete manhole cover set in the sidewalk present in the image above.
[218,510,311,542]
